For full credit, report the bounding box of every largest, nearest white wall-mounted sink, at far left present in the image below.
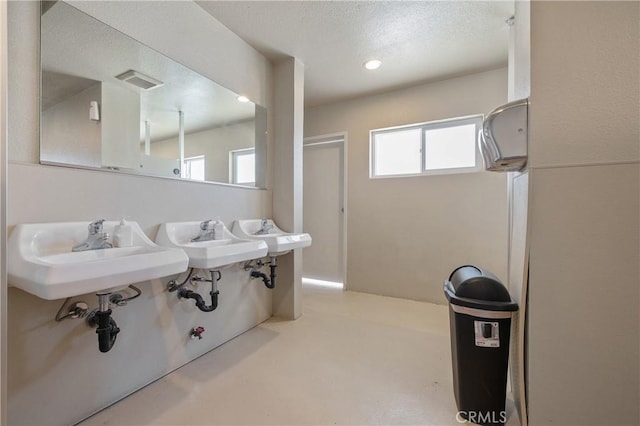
[7,221,188,300]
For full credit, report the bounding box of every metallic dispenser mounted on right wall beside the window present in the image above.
[478,99,529,172]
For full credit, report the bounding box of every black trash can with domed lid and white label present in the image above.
[444,265,518,425]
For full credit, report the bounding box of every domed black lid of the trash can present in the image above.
[444,265,518,311]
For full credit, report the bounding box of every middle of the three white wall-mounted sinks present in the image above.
[156,222,267,270]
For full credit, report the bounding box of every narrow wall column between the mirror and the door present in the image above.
[273,58,304,319]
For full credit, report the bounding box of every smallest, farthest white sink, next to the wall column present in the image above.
[233,219,311,256]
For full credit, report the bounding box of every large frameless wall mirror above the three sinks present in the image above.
[40,1,267,188]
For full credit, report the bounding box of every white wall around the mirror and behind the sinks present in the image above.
[3,2,273,425]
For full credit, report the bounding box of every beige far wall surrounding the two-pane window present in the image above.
[304,68,508,304]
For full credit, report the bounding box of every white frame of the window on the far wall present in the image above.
[369,114,484,179]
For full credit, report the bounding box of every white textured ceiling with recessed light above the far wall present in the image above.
[197,0,514,106]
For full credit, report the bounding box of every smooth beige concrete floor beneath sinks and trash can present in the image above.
[81,286,519,426]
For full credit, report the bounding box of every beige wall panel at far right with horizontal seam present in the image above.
[528,1,640,425]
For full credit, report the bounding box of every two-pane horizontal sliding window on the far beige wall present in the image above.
[369,116,482,178]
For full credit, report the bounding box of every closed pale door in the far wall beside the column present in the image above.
[302,133,346,288]
